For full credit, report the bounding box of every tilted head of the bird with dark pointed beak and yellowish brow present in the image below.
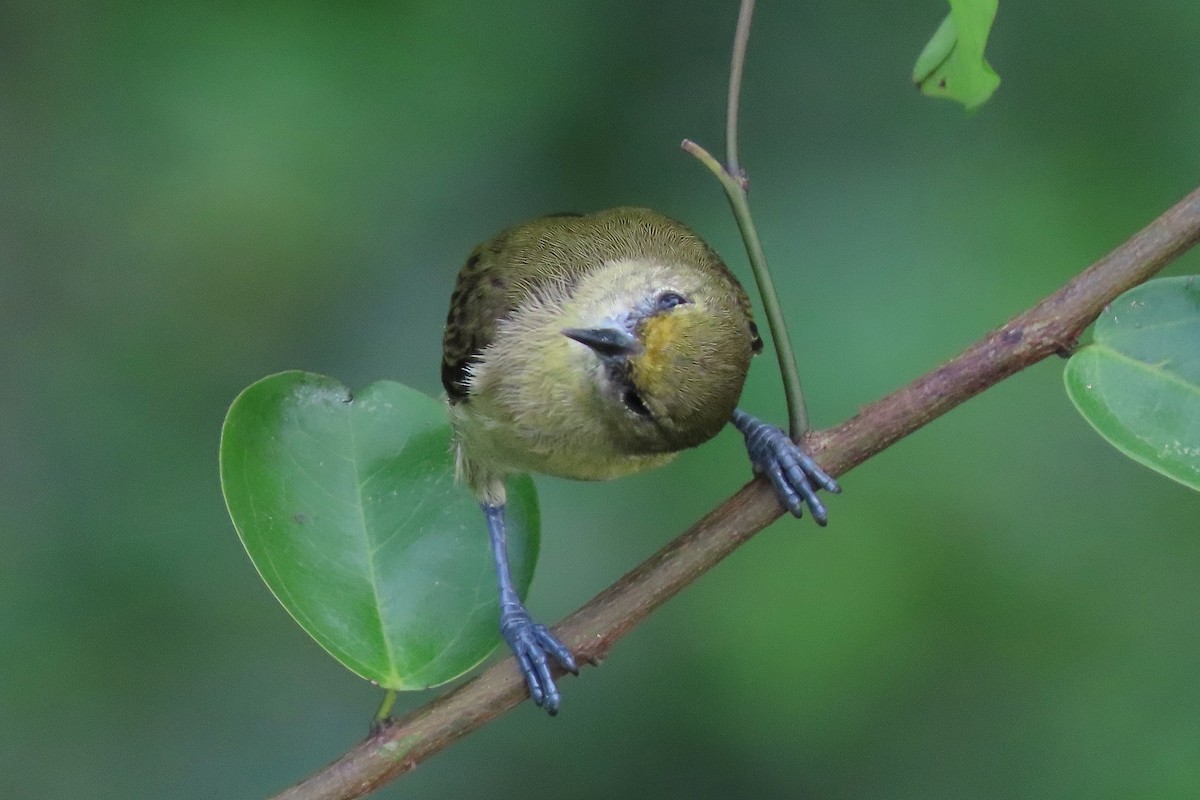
[562,260,757,452]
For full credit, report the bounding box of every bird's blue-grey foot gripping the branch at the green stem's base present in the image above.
[731,409,841,525]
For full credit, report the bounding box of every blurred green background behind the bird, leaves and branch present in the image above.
[0,0,1200,800]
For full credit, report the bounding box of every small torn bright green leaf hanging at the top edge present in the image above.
[912,0,1000,109]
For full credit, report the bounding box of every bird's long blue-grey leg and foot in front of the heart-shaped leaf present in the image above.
[480,503,580,716]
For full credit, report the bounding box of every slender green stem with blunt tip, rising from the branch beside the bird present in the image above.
[682,140,809,439]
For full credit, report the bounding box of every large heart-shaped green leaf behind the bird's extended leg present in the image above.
[221,372,539,690]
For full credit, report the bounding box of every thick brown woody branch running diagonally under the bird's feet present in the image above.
[277,190,1200,800]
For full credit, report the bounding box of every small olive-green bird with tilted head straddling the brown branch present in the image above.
[442,207,840,714]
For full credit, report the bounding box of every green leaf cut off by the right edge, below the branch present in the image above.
[1064,276,1200,491]
